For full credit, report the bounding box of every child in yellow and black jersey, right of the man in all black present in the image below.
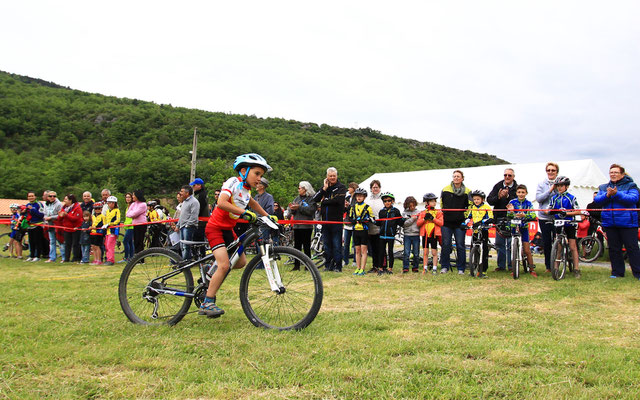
[347,187,373,276]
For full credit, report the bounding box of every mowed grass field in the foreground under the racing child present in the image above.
[0,252,640,399]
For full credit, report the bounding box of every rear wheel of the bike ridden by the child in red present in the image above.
[118,248,194,325]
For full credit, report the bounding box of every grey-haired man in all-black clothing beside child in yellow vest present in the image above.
[313,167,347,272]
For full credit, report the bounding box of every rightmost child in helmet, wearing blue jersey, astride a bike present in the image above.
[547,176,581,279]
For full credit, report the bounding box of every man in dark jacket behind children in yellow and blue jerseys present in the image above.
[487,168,518,271]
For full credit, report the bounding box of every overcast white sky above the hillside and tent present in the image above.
[0,0,640,179]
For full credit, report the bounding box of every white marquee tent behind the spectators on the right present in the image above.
[360,159,609,210]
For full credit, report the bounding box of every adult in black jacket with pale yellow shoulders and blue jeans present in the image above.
[434,169,471,275]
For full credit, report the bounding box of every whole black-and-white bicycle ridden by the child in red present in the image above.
[118,217,323,330]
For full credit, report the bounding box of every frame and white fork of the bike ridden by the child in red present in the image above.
[145,216,285,304]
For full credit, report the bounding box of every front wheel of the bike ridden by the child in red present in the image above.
[240,247,323,330]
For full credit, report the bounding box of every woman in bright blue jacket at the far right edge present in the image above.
[594,164,640,279]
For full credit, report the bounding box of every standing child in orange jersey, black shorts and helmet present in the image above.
[418,193,444,274]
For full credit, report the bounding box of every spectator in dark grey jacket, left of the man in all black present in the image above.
[287,181,316,270]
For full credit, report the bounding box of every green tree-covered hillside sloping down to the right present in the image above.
[0,72,504,201]
